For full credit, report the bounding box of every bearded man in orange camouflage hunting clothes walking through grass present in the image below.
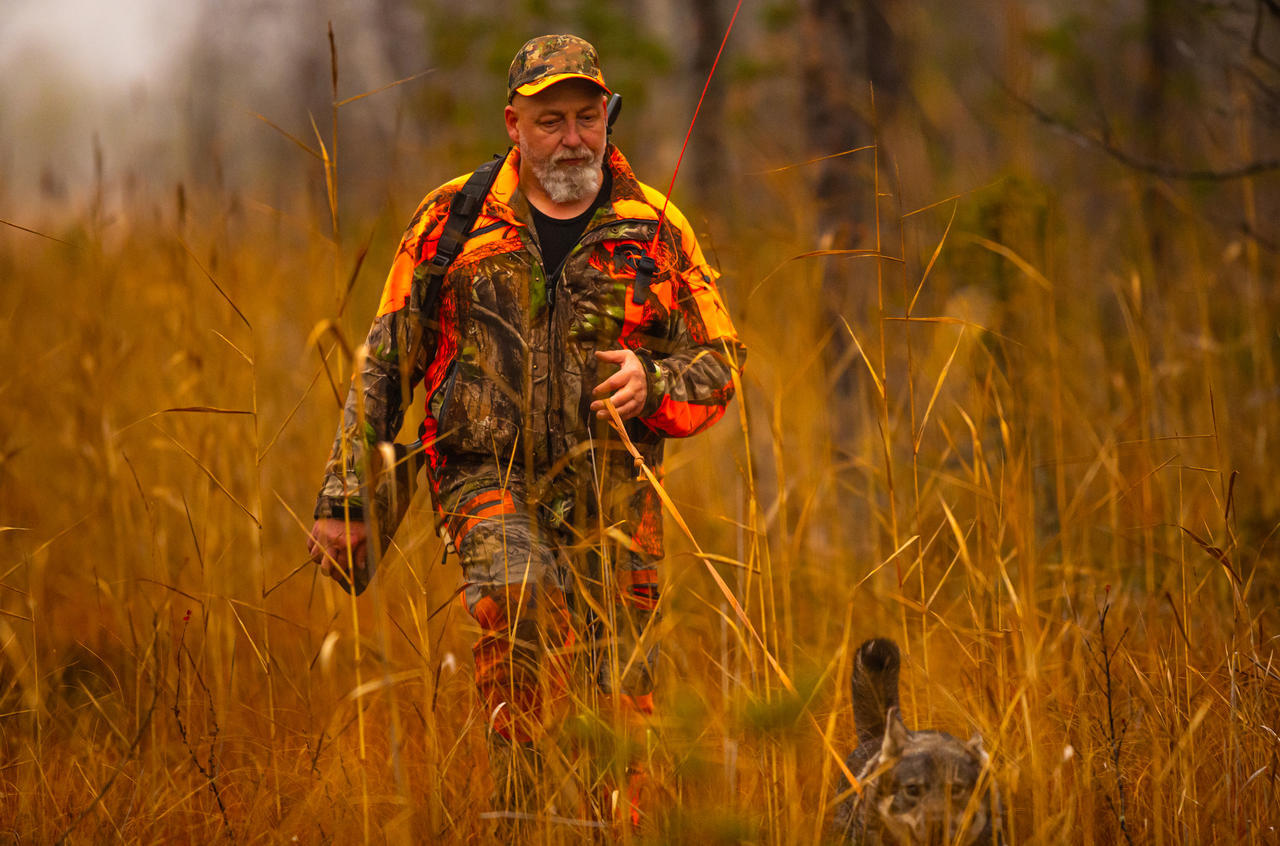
[310,35,745,824]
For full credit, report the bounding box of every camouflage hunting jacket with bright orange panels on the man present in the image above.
[315,146,745,550]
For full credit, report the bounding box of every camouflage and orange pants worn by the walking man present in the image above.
[438,466,658,744]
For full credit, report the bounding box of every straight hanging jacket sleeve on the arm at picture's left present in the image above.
[315,195,448,520]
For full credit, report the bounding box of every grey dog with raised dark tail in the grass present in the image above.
[833,637,1000,846]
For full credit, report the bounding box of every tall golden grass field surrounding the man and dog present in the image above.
[0,113,1280,843]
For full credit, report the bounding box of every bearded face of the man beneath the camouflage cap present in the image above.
[506,79,608,204]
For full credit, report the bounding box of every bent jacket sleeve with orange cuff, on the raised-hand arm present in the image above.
[636,206,746,438]
